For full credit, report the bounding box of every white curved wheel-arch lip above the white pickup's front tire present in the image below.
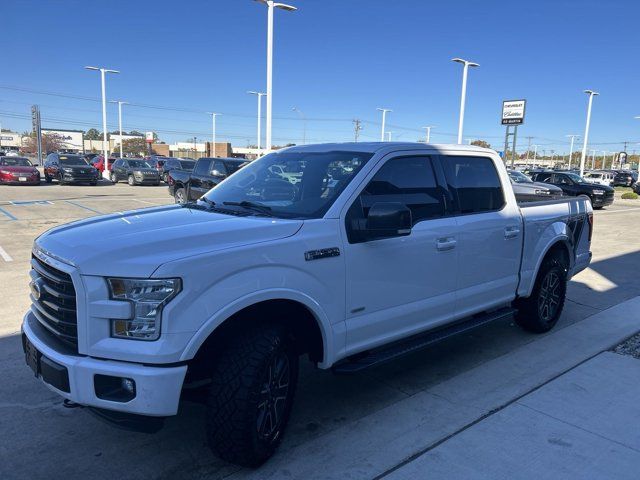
[180,288,335,368]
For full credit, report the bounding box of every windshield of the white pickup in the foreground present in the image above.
[205,151,373,218]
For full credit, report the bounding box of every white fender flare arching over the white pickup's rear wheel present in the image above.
[518,222,574,297]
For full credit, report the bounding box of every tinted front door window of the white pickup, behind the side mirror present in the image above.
[360,157,445,225]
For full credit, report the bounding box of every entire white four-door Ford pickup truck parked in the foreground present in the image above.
[22,143,593,466]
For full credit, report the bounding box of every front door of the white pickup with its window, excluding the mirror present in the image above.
[343,152,458,354]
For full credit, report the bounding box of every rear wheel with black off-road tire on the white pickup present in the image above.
[515,257,567,333]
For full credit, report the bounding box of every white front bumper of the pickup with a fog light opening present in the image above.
[22,311,187,417]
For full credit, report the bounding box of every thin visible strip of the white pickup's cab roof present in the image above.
[277,142,495,153]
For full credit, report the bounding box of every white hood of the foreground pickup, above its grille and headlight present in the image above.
[35,205,303,277]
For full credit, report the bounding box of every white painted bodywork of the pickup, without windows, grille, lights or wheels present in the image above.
[23,143,591,415]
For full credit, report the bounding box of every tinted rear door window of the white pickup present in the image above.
[442,156,504,214]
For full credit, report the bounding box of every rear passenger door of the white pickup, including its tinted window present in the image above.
[439,154,522,318]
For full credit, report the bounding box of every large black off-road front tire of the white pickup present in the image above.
[206,325,298,467]
